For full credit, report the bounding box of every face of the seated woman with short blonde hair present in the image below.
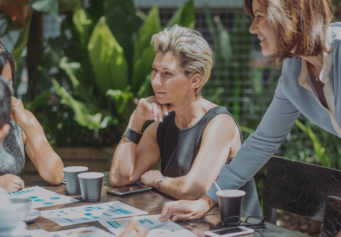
[151,52,194,104]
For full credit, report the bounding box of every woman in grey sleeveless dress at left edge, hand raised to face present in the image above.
[0,43,64,192]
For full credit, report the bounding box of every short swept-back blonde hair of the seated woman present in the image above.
[151,25,213,97]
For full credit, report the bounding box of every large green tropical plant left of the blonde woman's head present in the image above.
[19,0,195,146]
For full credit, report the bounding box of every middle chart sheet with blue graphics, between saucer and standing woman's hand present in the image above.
[41,201,148,226]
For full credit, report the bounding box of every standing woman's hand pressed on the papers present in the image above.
[159,200,206,221]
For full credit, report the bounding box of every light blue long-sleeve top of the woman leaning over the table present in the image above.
[207,23,341,202]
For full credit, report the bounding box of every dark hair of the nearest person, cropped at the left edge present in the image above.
[0,76,12,128]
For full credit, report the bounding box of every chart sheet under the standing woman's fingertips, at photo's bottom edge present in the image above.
[99,215,197,237]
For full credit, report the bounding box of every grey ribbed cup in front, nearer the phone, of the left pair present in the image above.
[78,172,104,202]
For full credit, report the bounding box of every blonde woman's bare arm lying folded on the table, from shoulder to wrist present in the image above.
[141,114,241,199]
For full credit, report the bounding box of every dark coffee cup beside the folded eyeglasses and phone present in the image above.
[216,189,245,225]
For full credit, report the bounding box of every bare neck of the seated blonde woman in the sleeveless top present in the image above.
[171,92,205,129]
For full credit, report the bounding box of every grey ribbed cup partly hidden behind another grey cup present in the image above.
[63,166,89,195]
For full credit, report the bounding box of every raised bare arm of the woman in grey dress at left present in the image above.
[11,97,64,185]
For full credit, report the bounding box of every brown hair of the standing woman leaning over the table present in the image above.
[244,0,333,62]
